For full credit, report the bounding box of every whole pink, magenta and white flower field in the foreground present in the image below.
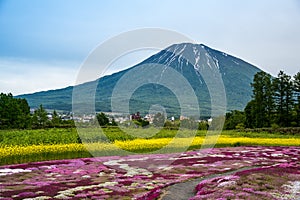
[0,147,300,200]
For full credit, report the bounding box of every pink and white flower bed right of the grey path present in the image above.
[190,166,300,200]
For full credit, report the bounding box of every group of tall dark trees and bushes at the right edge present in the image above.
[224,71,300,129]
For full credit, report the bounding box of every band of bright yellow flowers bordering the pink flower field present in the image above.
[0,136,300,164]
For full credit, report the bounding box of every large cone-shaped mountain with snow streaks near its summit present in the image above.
[18,43,261,117]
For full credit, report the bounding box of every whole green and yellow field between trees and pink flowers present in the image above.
[0,127,300,165]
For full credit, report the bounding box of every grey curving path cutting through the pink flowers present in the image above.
[159,166,258,200]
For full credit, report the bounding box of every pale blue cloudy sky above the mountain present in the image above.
[0,0,300,95]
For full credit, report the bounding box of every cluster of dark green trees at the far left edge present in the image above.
[0,93,74,129]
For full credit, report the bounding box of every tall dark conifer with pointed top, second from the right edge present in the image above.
[273,71,293,127]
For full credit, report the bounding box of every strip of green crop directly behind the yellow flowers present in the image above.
[0,127,300,147]
